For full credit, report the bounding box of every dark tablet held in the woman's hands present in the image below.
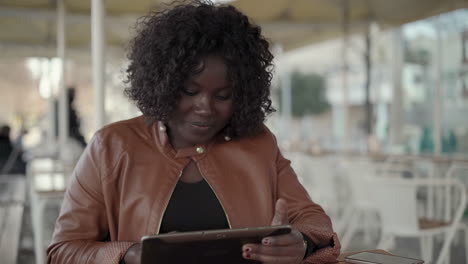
[141,225,291,264]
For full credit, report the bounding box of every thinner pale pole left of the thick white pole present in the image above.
[57,0,69,155]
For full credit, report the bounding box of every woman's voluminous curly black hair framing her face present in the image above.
[125,1,275,137]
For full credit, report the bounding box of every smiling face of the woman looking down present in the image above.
[167,56,233,148]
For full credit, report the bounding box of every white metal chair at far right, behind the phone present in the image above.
[371,178,466,264]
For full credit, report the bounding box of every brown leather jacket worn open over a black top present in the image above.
[47,117,340,264]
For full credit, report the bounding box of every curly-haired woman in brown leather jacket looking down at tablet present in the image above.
[48,1,340,264]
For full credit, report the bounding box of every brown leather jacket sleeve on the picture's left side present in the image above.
[47,136,135,264]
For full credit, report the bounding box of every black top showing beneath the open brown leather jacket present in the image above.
[159,179,229,234]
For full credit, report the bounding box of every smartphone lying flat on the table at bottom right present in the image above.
[345,252,424,264]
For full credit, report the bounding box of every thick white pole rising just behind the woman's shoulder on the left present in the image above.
[91,0,106,129]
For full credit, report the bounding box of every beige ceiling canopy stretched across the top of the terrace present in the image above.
[0,0,468,56]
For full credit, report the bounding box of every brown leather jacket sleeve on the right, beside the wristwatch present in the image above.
[276,149,341,264]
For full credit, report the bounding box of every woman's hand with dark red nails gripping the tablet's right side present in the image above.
[242,199,307,264]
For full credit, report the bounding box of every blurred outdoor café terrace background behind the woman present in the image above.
[0,0,468,263]
